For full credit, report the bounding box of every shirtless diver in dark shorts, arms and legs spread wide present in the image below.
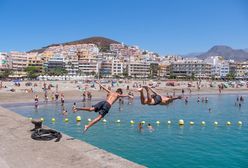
[76,82,134,132]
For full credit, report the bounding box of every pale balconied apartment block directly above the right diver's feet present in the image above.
[128,62,150,78]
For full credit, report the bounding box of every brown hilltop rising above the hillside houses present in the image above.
[29,37,120,53]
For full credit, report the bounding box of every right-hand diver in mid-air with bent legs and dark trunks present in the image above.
[138,86,182,105]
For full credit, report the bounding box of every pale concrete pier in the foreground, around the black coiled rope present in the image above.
[0,106,143,168]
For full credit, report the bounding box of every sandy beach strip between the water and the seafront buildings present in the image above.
[0,81,248,104]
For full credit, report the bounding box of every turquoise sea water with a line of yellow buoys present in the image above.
[5,95,248,168]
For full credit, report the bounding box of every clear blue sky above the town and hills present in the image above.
[0,0,248,55]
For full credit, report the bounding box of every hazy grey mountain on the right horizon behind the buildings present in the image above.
[197,45,248,61]
